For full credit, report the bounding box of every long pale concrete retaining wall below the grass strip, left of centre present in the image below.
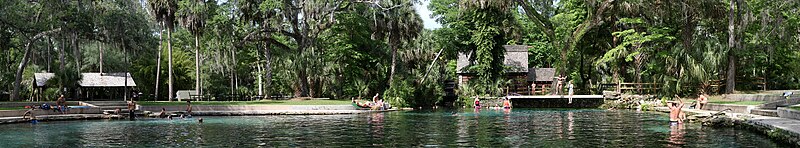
[139,105,356,112]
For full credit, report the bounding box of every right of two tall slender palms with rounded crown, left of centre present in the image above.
[178,0,207,95]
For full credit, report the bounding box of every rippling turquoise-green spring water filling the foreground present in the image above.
[0,109,786,148]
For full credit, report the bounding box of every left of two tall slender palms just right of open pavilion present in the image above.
[148,0,178,101]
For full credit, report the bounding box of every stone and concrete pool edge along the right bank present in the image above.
[653,107,800,147]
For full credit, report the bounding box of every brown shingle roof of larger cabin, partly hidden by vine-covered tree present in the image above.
[456,45,528,73]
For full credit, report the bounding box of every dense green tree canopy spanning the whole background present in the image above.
[0,0,800,107]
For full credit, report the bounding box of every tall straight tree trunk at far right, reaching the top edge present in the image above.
[725,0,736,94]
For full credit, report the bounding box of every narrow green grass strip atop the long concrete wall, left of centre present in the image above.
[137,100,350,106]
